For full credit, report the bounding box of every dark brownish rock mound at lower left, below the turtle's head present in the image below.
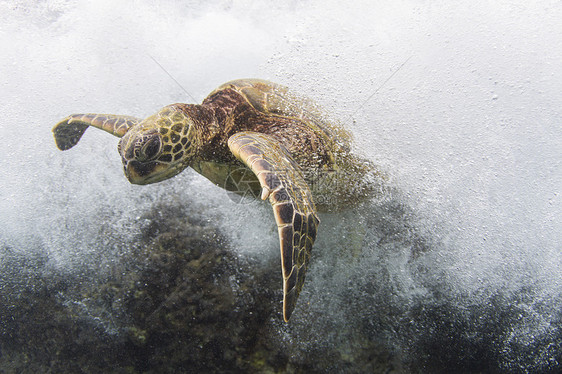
[0,206,306,373]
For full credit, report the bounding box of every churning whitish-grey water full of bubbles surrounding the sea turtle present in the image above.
[0,1,562,372]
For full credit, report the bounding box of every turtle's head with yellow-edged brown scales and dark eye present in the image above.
[118,104,196,184]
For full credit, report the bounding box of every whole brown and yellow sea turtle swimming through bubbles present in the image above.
[53,79,380,321]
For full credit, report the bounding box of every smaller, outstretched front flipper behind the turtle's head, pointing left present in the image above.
[53,114,141,151]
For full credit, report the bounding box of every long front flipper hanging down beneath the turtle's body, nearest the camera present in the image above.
[228,132,320,322]
